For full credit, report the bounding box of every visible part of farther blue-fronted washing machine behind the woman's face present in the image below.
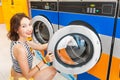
[30,0,59,44]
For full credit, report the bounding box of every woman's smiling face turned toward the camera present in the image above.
[17,17,33,39]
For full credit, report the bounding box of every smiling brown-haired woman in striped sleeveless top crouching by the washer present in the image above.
[8,13,56,80]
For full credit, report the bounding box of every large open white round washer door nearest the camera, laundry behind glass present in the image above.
[48,25,102,74]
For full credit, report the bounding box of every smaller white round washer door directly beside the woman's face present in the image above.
[32,16,53,44]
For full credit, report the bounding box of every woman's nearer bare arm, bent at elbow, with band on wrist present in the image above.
[13,44,44,79]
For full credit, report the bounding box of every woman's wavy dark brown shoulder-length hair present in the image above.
[7,13,30,41]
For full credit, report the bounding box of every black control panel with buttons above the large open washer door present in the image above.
[59,2,116,16]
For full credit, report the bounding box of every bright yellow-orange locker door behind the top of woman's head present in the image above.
[2,0,29,30]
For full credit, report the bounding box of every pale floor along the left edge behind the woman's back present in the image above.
[0,24,12,80]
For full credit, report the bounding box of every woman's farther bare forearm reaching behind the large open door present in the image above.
[27,41,48,50]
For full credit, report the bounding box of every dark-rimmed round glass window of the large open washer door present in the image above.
[55,33,94,67]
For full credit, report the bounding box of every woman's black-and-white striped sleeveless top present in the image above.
[10,41,33,73]
